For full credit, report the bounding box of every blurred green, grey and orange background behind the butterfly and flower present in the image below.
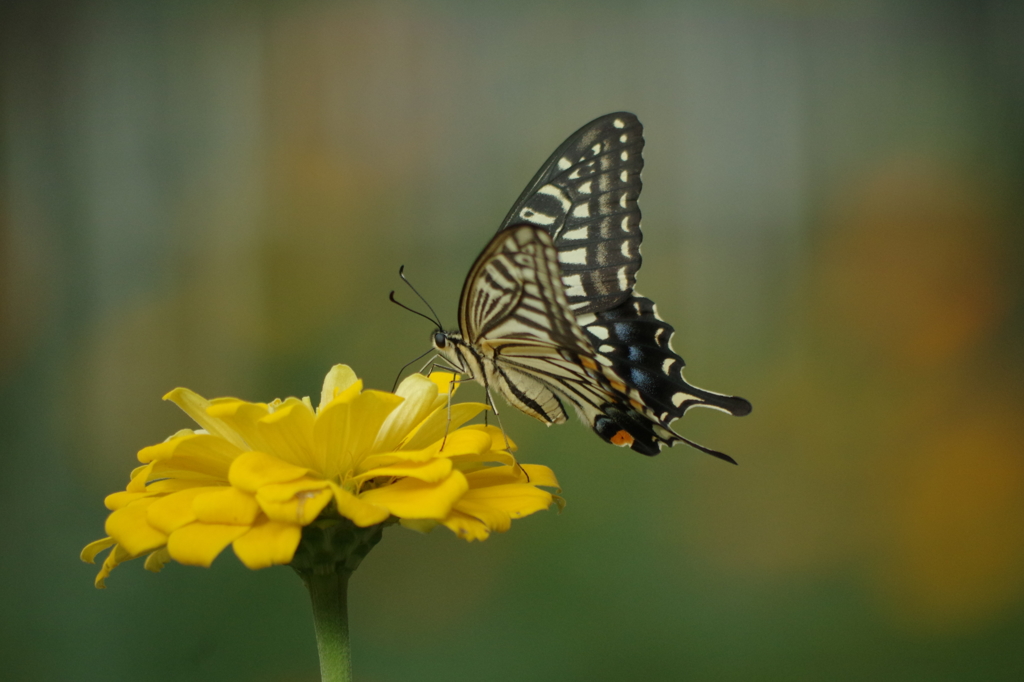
[0,0,1024,682]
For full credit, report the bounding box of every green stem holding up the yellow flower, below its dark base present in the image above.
[302,570,352,682]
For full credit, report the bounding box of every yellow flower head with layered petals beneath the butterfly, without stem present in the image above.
[82,365,562,587]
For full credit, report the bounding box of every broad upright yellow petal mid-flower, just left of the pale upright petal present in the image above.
[313,391,403,478]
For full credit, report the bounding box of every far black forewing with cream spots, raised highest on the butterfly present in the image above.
[500,112,644,314]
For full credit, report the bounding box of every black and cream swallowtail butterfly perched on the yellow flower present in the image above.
[432,112,751,464]
